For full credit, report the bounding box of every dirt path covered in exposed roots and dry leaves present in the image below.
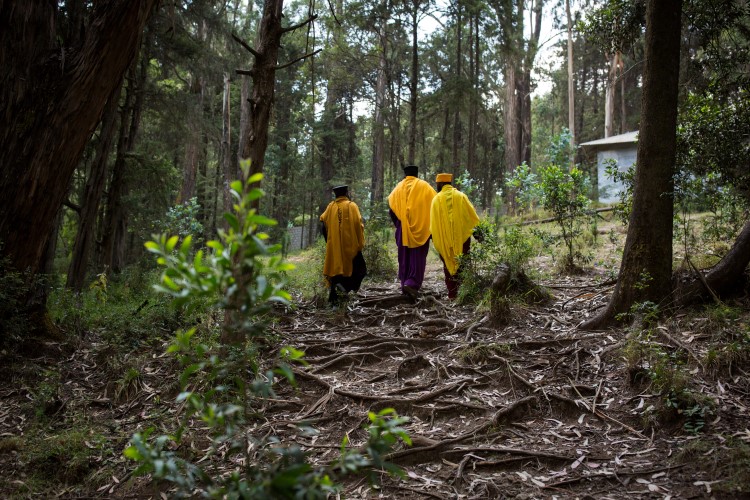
[266,269,748,498]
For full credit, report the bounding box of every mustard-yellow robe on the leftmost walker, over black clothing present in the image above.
[320,196,365,277]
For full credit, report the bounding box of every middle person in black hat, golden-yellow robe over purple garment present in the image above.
[388,165,436,299]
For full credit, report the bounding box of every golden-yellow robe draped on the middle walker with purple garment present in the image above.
[388,176,437,248]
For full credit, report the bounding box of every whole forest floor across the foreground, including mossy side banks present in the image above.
[0,254,750,499]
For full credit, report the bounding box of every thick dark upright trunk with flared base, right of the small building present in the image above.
[582,0,682,328]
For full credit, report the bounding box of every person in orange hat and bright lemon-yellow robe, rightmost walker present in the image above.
[430,174,482,299]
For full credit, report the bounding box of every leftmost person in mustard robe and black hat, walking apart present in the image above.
[320,186,367,307]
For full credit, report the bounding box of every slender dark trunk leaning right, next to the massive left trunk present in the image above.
[65,84,122,292]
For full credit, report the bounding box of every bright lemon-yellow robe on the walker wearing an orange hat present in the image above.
[430,184,479,275]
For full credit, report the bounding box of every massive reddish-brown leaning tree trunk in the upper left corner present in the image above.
[0,0,156,273]
